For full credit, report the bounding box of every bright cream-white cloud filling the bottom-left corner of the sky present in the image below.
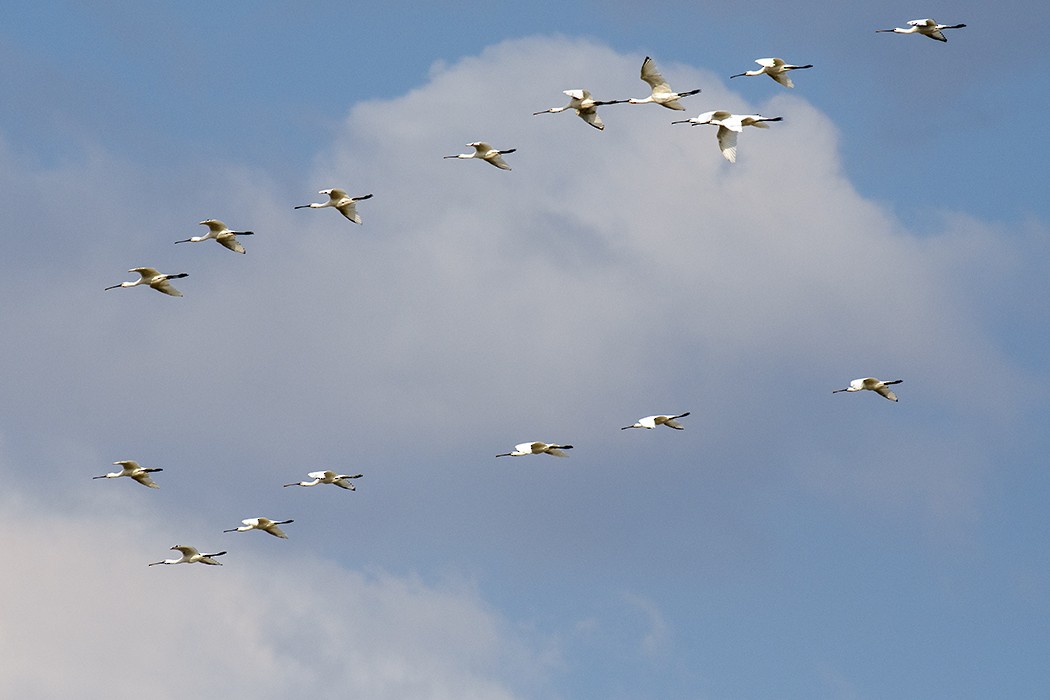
[0,489,546,699]
